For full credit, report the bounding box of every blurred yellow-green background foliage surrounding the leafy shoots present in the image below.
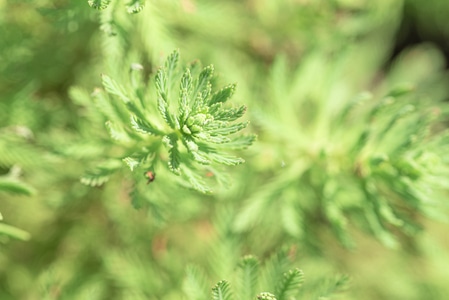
[0,0,449,300]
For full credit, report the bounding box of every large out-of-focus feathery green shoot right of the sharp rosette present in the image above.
[235,45,449,247]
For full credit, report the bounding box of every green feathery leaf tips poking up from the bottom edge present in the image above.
[183,251,348,300]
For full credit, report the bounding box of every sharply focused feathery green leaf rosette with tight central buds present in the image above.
[82,51,255,193]
